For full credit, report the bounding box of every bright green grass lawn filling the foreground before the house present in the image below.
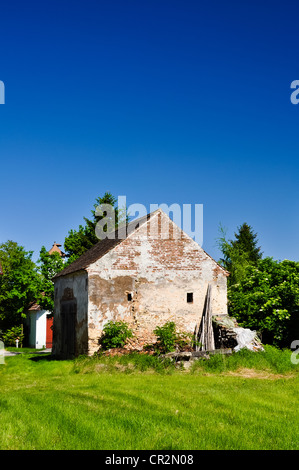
[0,349,299,450]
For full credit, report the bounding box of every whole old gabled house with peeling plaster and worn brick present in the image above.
[52,209,228,357]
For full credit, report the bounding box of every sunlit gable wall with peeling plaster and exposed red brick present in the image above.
[87,212,227,354]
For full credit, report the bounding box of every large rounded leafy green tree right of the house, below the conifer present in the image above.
[228,258,299,347]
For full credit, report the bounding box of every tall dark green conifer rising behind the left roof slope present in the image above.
[64,192,127,264]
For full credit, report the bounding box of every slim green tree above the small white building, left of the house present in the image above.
[37,246,65,312]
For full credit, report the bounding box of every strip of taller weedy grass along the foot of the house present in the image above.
[5,345,299,375]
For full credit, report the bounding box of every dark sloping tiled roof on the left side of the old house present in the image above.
[53,209,154,279]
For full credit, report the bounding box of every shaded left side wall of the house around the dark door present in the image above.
[52,271,88,356]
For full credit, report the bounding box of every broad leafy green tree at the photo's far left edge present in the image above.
[0,240,41,330]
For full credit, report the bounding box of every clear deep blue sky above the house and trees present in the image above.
[0,0,299,260]
